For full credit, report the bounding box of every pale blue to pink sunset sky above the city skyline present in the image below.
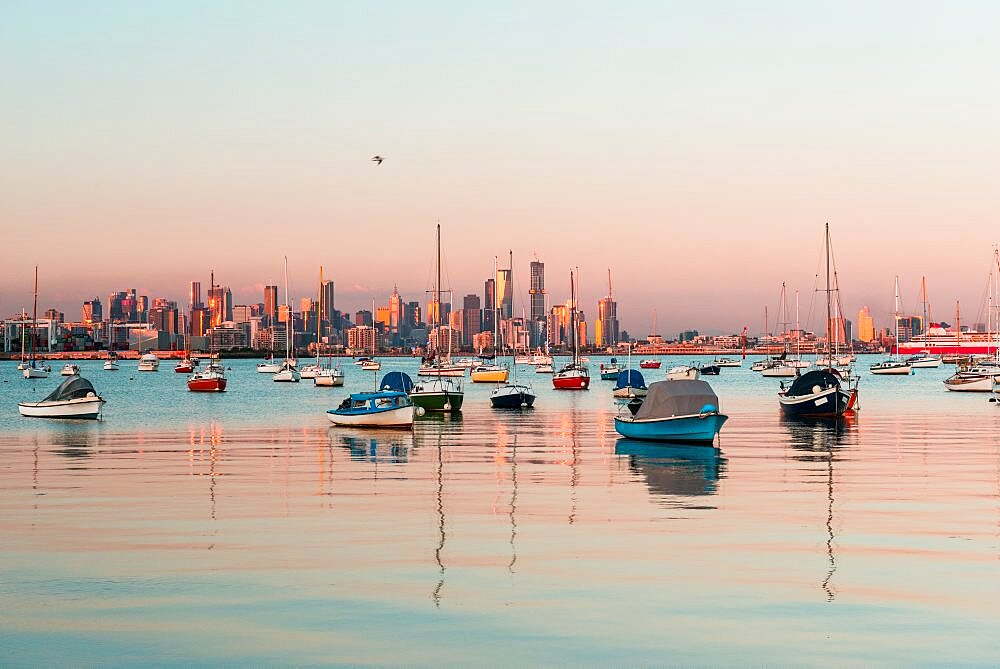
[0,0,1000,334]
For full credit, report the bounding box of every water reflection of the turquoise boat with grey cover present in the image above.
[615,439,726,497]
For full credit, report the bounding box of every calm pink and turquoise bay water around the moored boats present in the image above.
[0,358,1000,666]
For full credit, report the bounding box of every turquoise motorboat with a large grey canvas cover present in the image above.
[615,380,729,443]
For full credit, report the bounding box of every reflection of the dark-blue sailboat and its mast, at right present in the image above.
[782,413,857,602]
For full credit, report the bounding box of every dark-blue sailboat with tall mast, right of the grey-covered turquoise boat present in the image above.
[778,223,858,418]
